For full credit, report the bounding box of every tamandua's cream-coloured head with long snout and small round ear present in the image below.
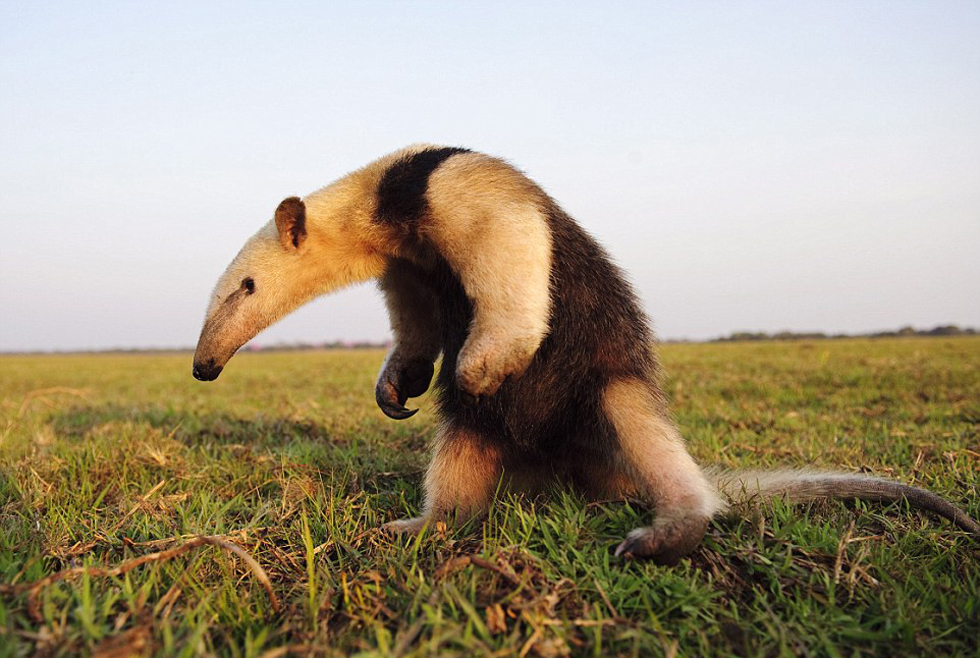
[193,197,384,381]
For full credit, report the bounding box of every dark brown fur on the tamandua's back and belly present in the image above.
[394,202,662,491]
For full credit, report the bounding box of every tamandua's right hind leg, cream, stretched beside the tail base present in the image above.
[602,379,722,564]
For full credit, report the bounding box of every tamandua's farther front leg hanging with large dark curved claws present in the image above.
[374,259,440,420]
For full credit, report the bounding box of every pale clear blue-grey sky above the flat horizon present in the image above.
[0,0,980,351]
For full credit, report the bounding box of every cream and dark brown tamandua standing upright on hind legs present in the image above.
[193,145,980,563]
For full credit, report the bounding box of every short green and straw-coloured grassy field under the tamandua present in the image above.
[0,338,980,658]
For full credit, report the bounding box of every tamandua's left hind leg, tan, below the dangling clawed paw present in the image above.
[384,426,502,534]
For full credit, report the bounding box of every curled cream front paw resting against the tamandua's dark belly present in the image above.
[456,339,540,402]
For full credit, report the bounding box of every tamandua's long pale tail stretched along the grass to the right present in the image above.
[708,470,980,537]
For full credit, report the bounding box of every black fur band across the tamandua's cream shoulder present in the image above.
[375,147,470,225]
